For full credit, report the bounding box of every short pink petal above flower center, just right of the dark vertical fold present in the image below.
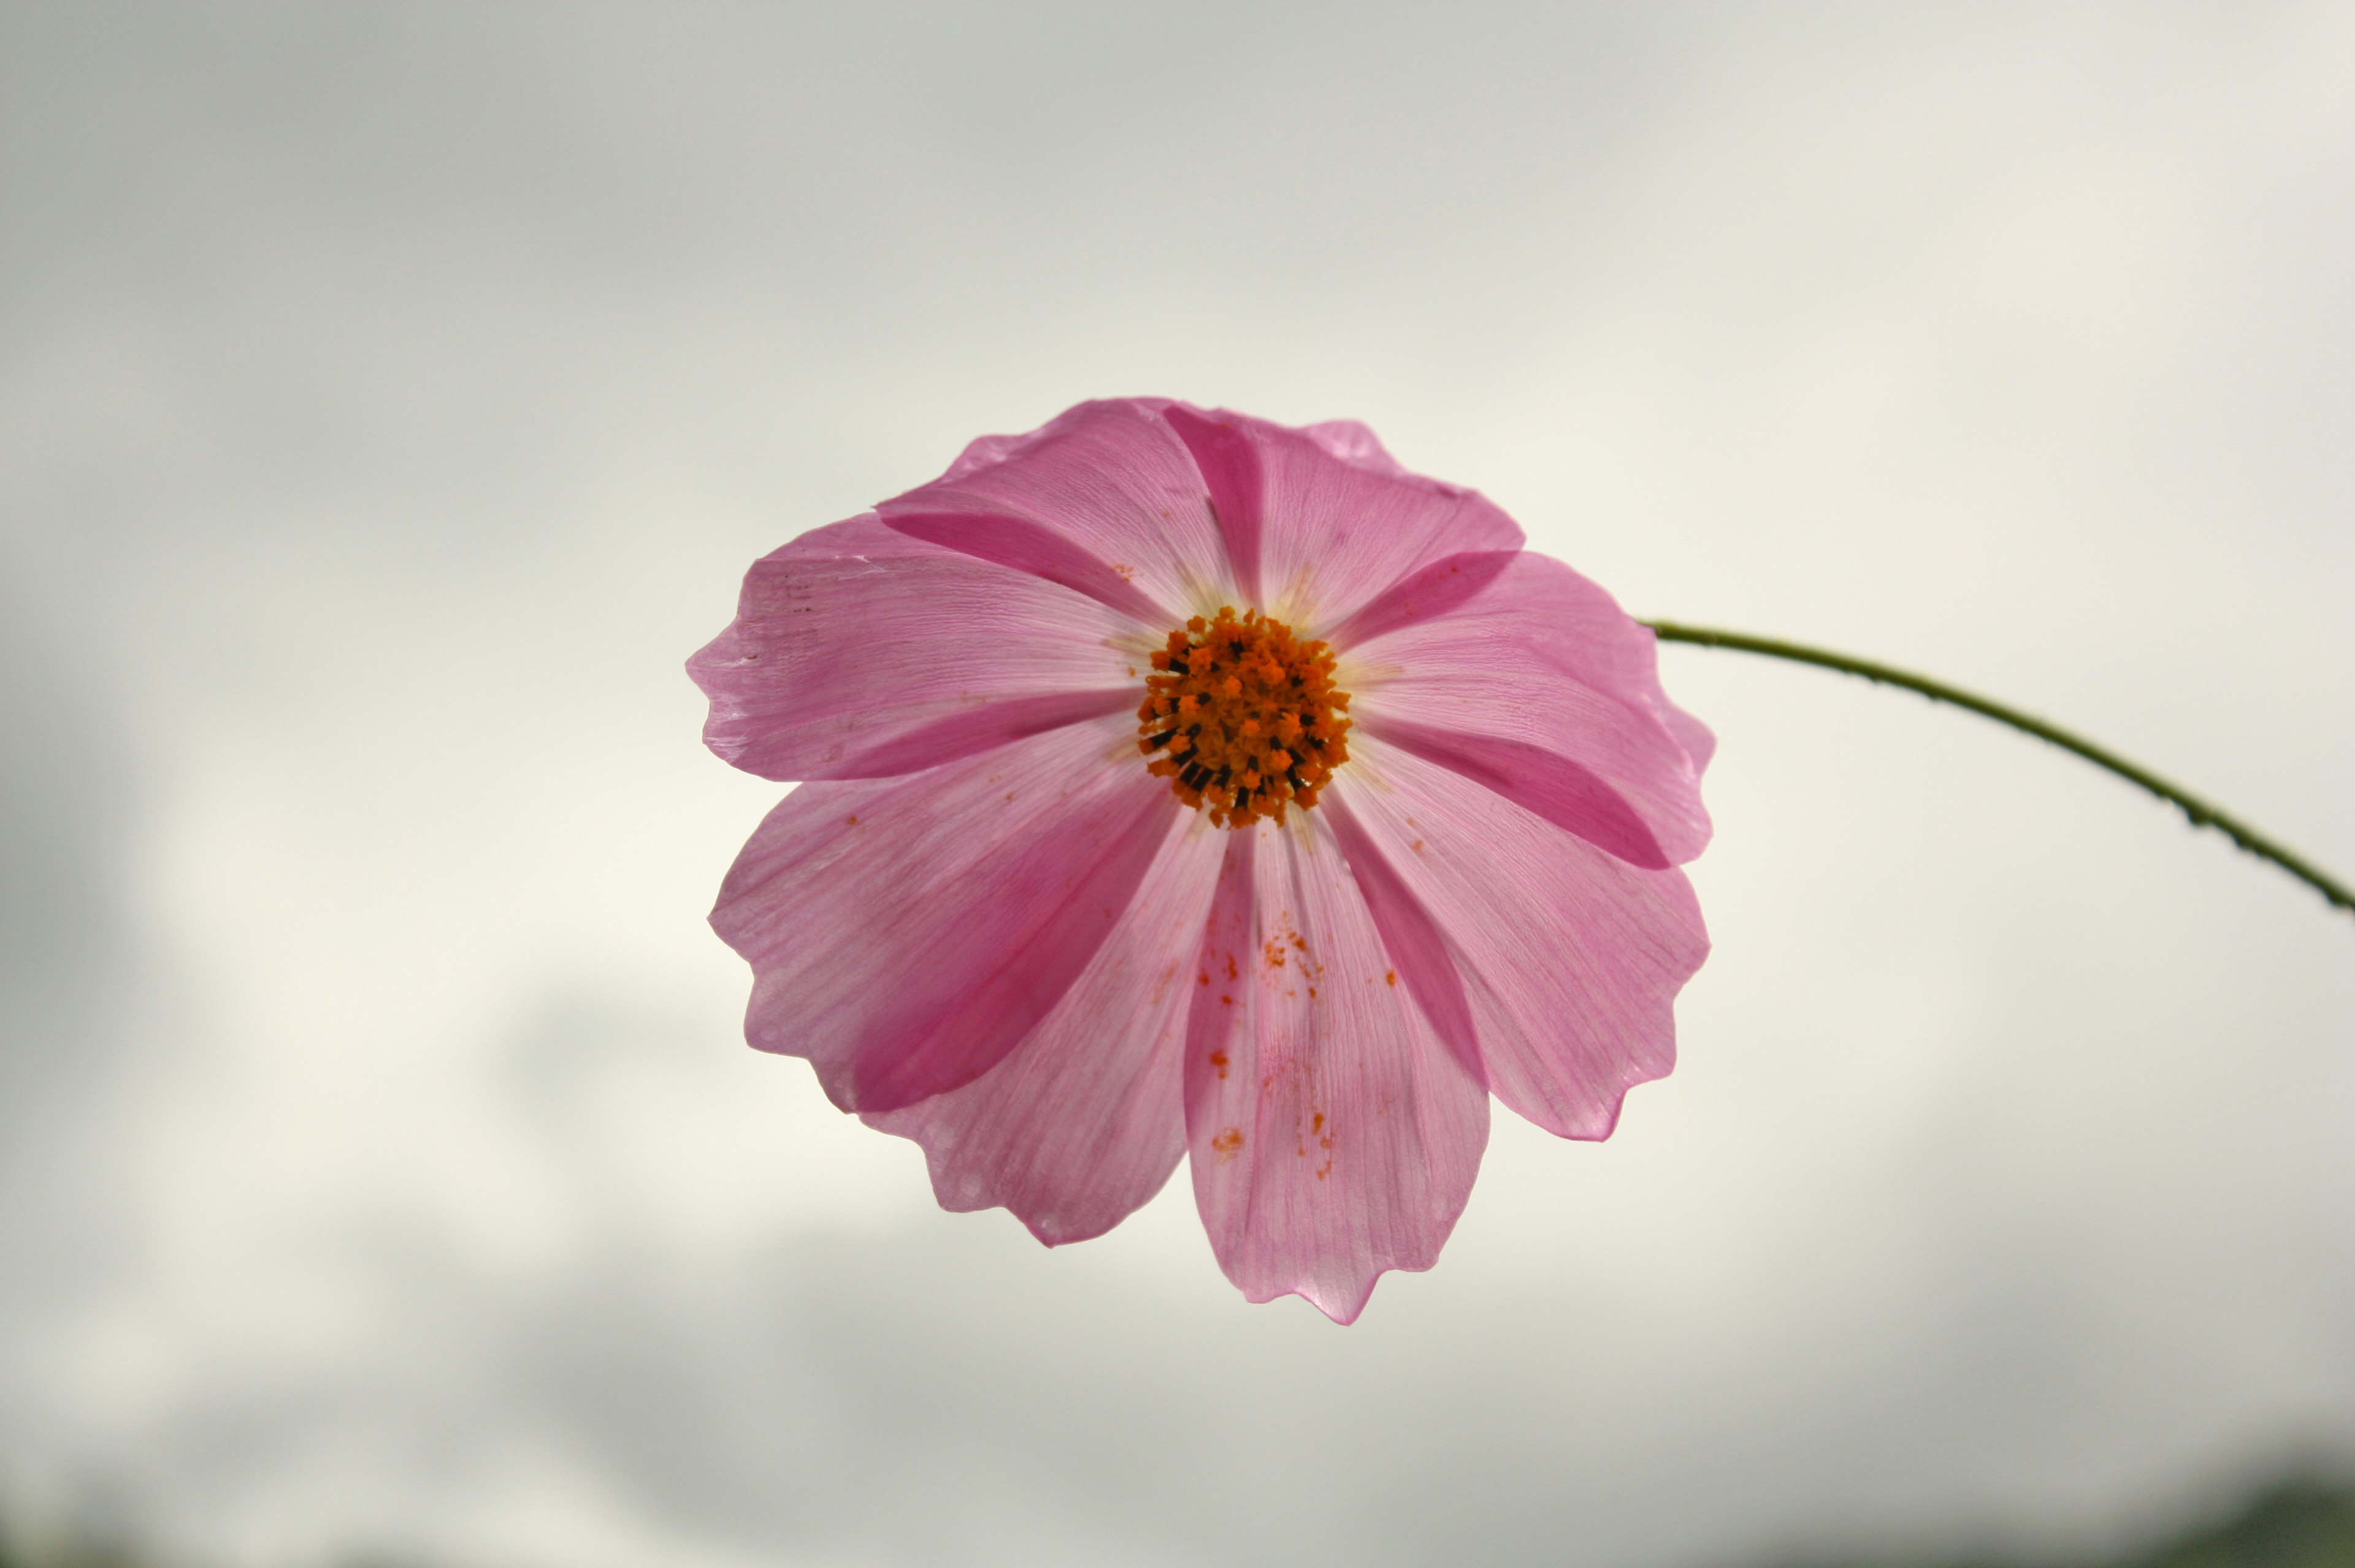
[1206,410,1522,636]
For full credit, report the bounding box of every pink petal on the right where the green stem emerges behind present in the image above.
[1338,551,1710,869]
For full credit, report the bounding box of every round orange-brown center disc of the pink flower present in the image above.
[1138,608,1349,828]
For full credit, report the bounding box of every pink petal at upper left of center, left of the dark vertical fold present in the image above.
[876,398,1236,631]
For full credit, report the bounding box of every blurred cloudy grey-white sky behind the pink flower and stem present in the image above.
[0,0,2355,1568]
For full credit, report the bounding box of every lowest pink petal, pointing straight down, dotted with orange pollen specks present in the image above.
[1185,813,1488,1323]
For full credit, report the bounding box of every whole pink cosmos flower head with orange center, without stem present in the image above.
[687,398,1712,1323]
